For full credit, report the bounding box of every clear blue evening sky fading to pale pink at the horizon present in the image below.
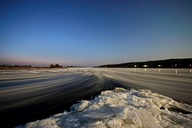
[0,0,192,66]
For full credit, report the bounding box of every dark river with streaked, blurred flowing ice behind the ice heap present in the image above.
[0,68,192,126]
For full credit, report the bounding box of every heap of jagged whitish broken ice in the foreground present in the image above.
[18,88,192,128]
